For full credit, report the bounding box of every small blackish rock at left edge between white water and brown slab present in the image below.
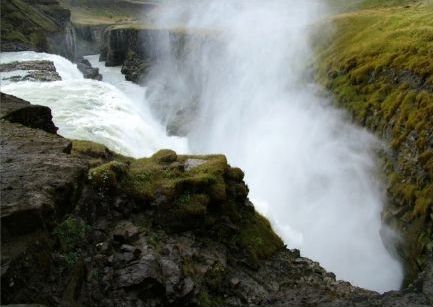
[0,93,57,133]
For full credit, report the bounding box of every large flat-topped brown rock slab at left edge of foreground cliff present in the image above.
[0,122,86,239]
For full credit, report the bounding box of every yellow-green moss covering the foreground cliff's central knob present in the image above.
[71,145,284,266]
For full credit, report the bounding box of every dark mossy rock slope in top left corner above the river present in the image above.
[1,0,75,59]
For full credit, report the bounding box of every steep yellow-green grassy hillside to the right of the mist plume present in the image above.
[316,0,433,286]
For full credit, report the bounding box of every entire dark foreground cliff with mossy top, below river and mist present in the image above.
[0,94,433,306]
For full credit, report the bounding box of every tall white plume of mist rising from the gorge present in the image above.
[147,0,402,291]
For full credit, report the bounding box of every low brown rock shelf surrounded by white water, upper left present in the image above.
[0,61,62,82]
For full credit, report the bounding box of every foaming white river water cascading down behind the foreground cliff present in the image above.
[0,52,187,157]
